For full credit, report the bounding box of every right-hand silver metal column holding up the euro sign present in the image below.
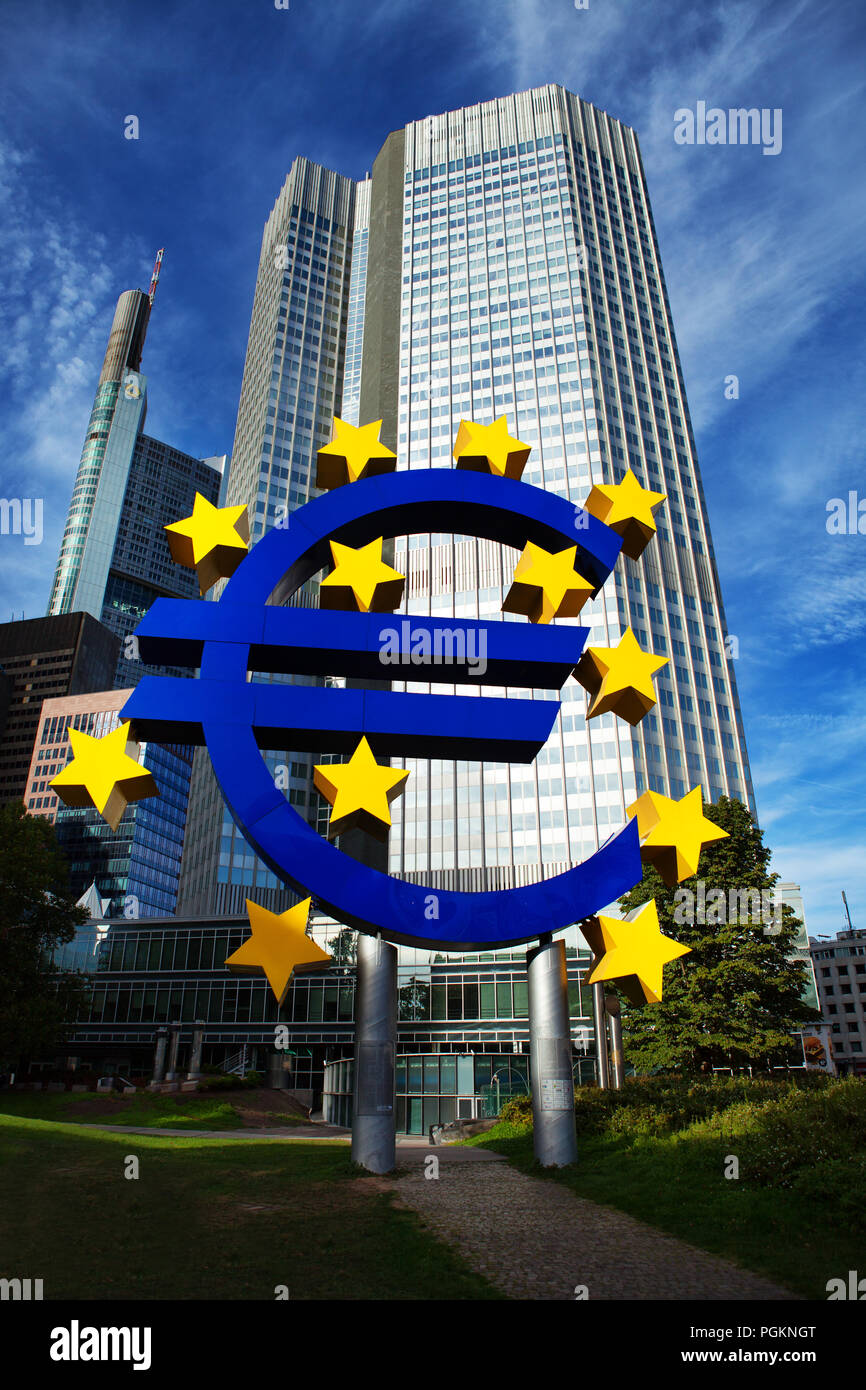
[527,937,577,1168]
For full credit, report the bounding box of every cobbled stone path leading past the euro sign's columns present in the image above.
[395,1148,796,1301]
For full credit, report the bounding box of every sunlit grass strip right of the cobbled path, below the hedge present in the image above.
[466,1123,865,1300]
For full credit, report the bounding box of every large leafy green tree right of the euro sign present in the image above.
[620,796,816,1072]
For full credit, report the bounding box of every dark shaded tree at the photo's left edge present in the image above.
[0,802,88,1063]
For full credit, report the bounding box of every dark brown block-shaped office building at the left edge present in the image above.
[0,613,120,802]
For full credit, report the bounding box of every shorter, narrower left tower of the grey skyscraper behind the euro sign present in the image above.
[178,158,363,916]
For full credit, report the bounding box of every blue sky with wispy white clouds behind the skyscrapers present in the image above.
[0,0,866,934]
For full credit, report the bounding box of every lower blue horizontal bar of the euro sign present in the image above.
[122,675,559,763]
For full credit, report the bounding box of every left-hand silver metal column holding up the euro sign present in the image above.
[352,933,398,1173]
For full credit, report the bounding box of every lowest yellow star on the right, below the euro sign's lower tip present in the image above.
[581,898,691,1004]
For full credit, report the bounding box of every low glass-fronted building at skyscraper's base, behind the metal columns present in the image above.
[48,917,595,1133]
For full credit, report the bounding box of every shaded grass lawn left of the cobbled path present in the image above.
[0,1112,500,1300]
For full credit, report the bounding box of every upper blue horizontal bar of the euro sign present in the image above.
[136,599,589,689]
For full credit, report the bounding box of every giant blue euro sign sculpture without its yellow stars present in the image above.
[122,468,642,949]
